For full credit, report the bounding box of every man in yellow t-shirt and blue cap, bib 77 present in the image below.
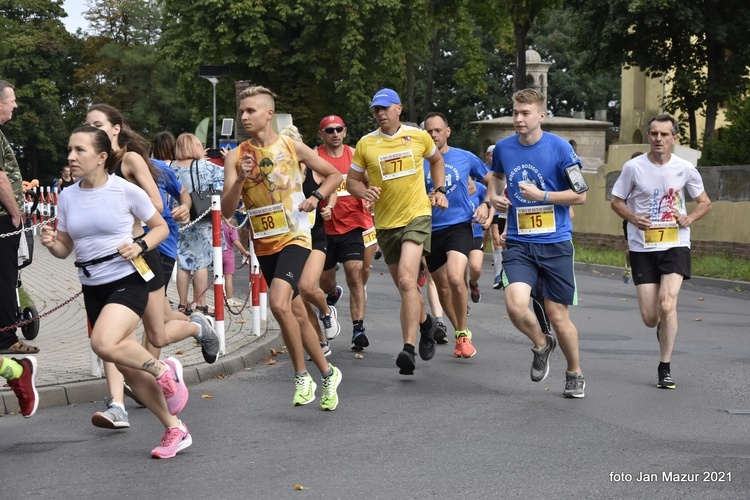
[346,89,448,375]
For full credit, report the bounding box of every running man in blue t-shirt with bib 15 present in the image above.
[487,89,588,398]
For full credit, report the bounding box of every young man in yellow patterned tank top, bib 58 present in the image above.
[221,87,342,411]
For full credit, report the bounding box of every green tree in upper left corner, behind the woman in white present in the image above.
[0,0,77,184]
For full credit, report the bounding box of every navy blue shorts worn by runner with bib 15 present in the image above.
[502,240,578,305]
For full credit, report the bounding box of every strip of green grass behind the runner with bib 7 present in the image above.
[575,246,750,281]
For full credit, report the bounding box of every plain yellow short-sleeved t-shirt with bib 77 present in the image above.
[352,125,436,229]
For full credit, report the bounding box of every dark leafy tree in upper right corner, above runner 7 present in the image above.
[567,0,750,147]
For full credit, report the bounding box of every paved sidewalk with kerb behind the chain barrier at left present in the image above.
[0,237,283,416]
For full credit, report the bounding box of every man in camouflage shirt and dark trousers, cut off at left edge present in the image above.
[0,80,39,354]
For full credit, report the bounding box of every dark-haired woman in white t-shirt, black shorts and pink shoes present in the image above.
[41,126,192,458]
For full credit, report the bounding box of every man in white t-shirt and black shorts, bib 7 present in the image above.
[611,115,711,389]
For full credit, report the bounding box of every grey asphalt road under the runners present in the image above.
[0,260,750,500]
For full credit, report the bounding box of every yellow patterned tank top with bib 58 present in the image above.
[236,135,311,256]
